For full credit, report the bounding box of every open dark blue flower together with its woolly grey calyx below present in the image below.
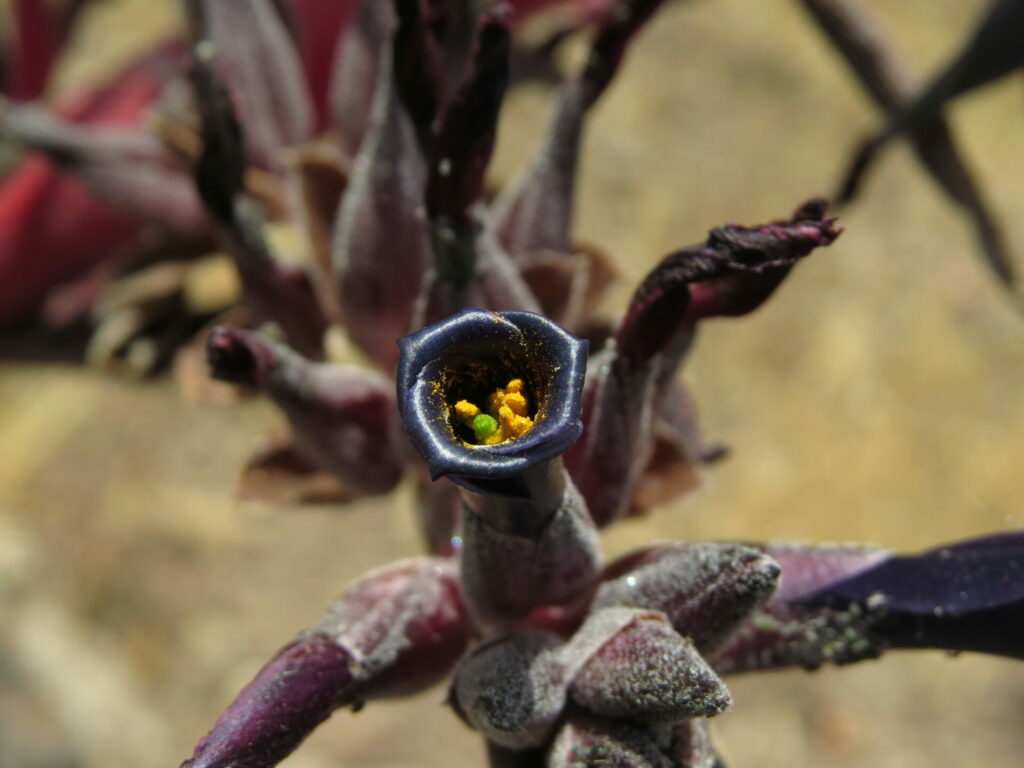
[398,310,600,623]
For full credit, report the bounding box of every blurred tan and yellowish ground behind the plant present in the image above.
[0,0,1024,768]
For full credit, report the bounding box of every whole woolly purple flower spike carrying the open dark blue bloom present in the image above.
[167,0,1024,768]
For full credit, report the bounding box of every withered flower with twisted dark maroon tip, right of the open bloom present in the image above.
[565,200,840,526]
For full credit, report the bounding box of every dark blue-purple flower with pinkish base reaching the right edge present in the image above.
[713,531,1024,672]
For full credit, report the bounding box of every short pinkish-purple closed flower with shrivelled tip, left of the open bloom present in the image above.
[207,327,403,495]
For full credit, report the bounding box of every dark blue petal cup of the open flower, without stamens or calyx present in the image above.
[397,309,587,497]
